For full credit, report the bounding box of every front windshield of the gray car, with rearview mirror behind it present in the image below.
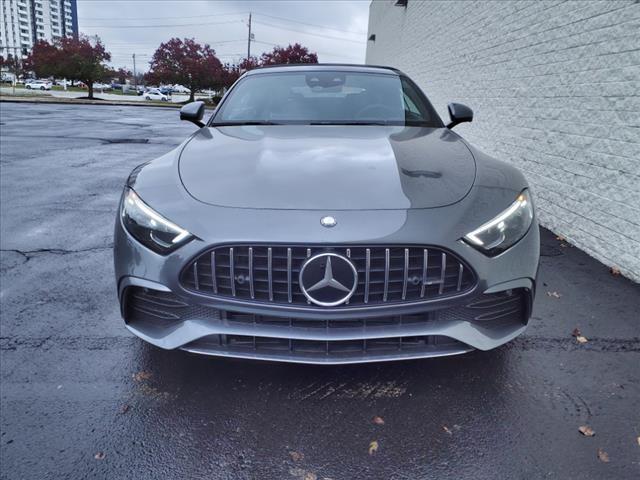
[211,71,442,127]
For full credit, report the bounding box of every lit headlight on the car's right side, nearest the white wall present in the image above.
[464,190,533,257]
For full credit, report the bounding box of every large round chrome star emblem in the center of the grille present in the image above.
[300,253,358,307]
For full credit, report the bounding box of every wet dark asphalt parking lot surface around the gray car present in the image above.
[0,103,640,480]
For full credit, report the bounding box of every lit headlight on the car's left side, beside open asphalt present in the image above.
[121,188,193,255]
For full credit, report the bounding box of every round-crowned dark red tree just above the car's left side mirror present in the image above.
[147,38,224,102]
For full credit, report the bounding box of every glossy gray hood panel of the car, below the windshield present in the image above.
[179,125,476,211]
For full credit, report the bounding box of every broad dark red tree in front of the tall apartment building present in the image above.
[27,35,111,98]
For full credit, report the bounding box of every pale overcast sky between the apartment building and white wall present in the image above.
[78,0,370,71]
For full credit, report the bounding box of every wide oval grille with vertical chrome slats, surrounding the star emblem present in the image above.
[181,245,476,308]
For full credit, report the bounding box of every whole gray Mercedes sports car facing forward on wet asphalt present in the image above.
[114,65,540,364]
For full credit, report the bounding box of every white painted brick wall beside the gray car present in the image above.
[367,0,640,281]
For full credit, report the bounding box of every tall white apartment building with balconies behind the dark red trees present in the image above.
[0,0,78,58]
